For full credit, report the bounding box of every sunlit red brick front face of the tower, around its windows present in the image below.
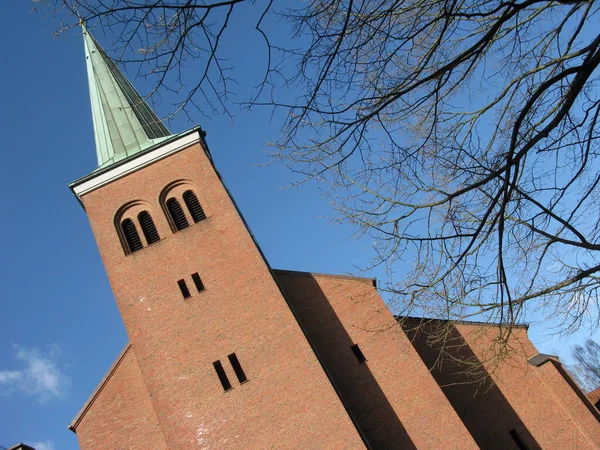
[77,139,364,450]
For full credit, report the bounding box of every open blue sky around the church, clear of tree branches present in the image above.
[0,1,587,450]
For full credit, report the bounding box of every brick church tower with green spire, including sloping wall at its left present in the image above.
[70,29,365,450]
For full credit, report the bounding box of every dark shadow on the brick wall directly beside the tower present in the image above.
[277,276,416,449]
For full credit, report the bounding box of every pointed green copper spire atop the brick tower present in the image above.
[82,25,171,168]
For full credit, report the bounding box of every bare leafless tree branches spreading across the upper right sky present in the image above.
[49,0,600,352]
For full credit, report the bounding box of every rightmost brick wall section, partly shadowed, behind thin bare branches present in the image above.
[406,322,600,449]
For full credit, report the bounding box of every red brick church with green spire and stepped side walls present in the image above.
[69,26,600,450]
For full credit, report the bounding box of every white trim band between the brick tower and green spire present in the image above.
[73,131,200,197]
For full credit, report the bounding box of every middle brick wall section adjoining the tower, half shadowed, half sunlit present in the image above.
[275,271,477,449]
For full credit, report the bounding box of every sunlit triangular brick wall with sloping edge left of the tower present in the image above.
[77,348,169,450]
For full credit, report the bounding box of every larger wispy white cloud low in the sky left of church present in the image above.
[0,345,71,402]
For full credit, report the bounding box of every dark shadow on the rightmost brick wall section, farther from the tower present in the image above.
[404,321,541,450]
